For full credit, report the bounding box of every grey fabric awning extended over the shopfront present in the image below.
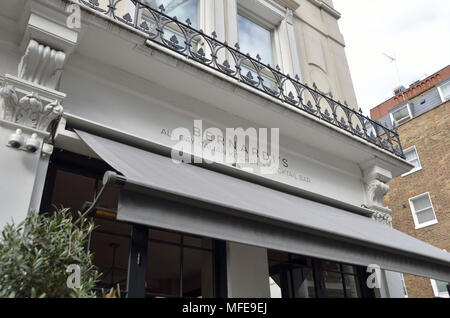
[77,131,450,282]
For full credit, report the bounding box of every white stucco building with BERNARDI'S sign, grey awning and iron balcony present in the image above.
[0,0,450,297]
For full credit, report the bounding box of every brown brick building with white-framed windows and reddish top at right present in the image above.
[371,66,450,297]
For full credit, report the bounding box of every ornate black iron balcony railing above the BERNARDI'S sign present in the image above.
[78,0,405,158]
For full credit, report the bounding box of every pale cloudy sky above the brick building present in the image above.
[333,0,450,114]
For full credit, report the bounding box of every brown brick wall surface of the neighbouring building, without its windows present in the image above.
[385,101,450,297]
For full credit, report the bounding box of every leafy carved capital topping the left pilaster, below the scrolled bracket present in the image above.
[0,76,63,131]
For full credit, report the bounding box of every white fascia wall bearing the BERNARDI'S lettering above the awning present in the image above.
[61,56,364,206]
